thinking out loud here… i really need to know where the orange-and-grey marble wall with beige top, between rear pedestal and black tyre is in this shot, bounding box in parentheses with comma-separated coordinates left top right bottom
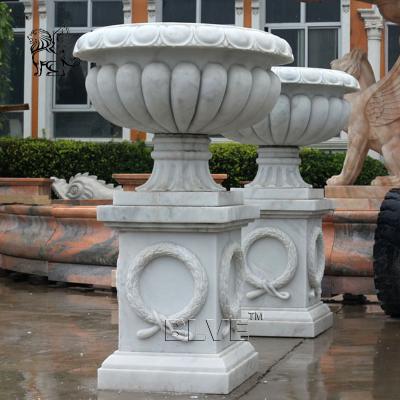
(323, 186, 392, 295)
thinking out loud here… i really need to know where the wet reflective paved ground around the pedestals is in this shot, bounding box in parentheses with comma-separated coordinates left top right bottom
(0, 277, 400, 400)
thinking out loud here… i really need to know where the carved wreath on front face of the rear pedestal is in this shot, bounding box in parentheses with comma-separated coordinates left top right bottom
(243, 228, 298, 300)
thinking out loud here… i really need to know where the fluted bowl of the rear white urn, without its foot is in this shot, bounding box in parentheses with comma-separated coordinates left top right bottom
(226, 67, 359, 146)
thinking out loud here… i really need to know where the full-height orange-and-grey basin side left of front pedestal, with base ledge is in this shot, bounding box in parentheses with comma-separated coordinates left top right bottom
(0, 200, 118, 287)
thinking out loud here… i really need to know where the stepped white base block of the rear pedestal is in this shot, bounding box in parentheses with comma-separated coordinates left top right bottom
(242, 303, 333, 338)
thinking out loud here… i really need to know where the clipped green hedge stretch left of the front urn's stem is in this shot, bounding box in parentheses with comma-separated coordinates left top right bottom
(0, 138, 153, 182)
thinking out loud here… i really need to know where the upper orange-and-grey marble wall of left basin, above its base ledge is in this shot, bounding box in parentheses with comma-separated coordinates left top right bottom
(0, 205, 118, 267)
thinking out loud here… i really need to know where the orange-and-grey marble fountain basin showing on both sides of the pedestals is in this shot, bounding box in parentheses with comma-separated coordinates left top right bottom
(0, 202, 376, 295)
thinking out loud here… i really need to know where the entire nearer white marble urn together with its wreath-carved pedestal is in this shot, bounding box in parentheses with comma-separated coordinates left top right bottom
(74, 23, 293, 393)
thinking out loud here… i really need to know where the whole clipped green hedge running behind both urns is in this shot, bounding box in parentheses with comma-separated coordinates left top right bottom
(0, 138, 387, 187)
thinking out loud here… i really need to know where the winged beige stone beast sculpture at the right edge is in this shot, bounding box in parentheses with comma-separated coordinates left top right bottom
(327, 49, 400, 185)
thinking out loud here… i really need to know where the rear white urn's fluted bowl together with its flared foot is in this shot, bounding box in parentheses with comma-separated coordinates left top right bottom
(226, 67, 359, 192)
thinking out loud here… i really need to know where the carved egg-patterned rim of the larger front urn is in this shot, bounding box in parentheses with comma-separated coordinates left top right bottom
(73, 22, 293, 65)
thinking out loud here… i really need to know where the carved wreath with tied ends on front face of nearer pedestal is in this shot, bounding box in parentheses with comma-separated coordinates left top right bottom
(125, 242, 208, 342)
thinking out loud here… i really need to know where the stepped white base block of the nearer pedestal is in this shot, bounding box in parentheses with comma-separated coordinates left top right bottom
(98, 342, 258, 394)
